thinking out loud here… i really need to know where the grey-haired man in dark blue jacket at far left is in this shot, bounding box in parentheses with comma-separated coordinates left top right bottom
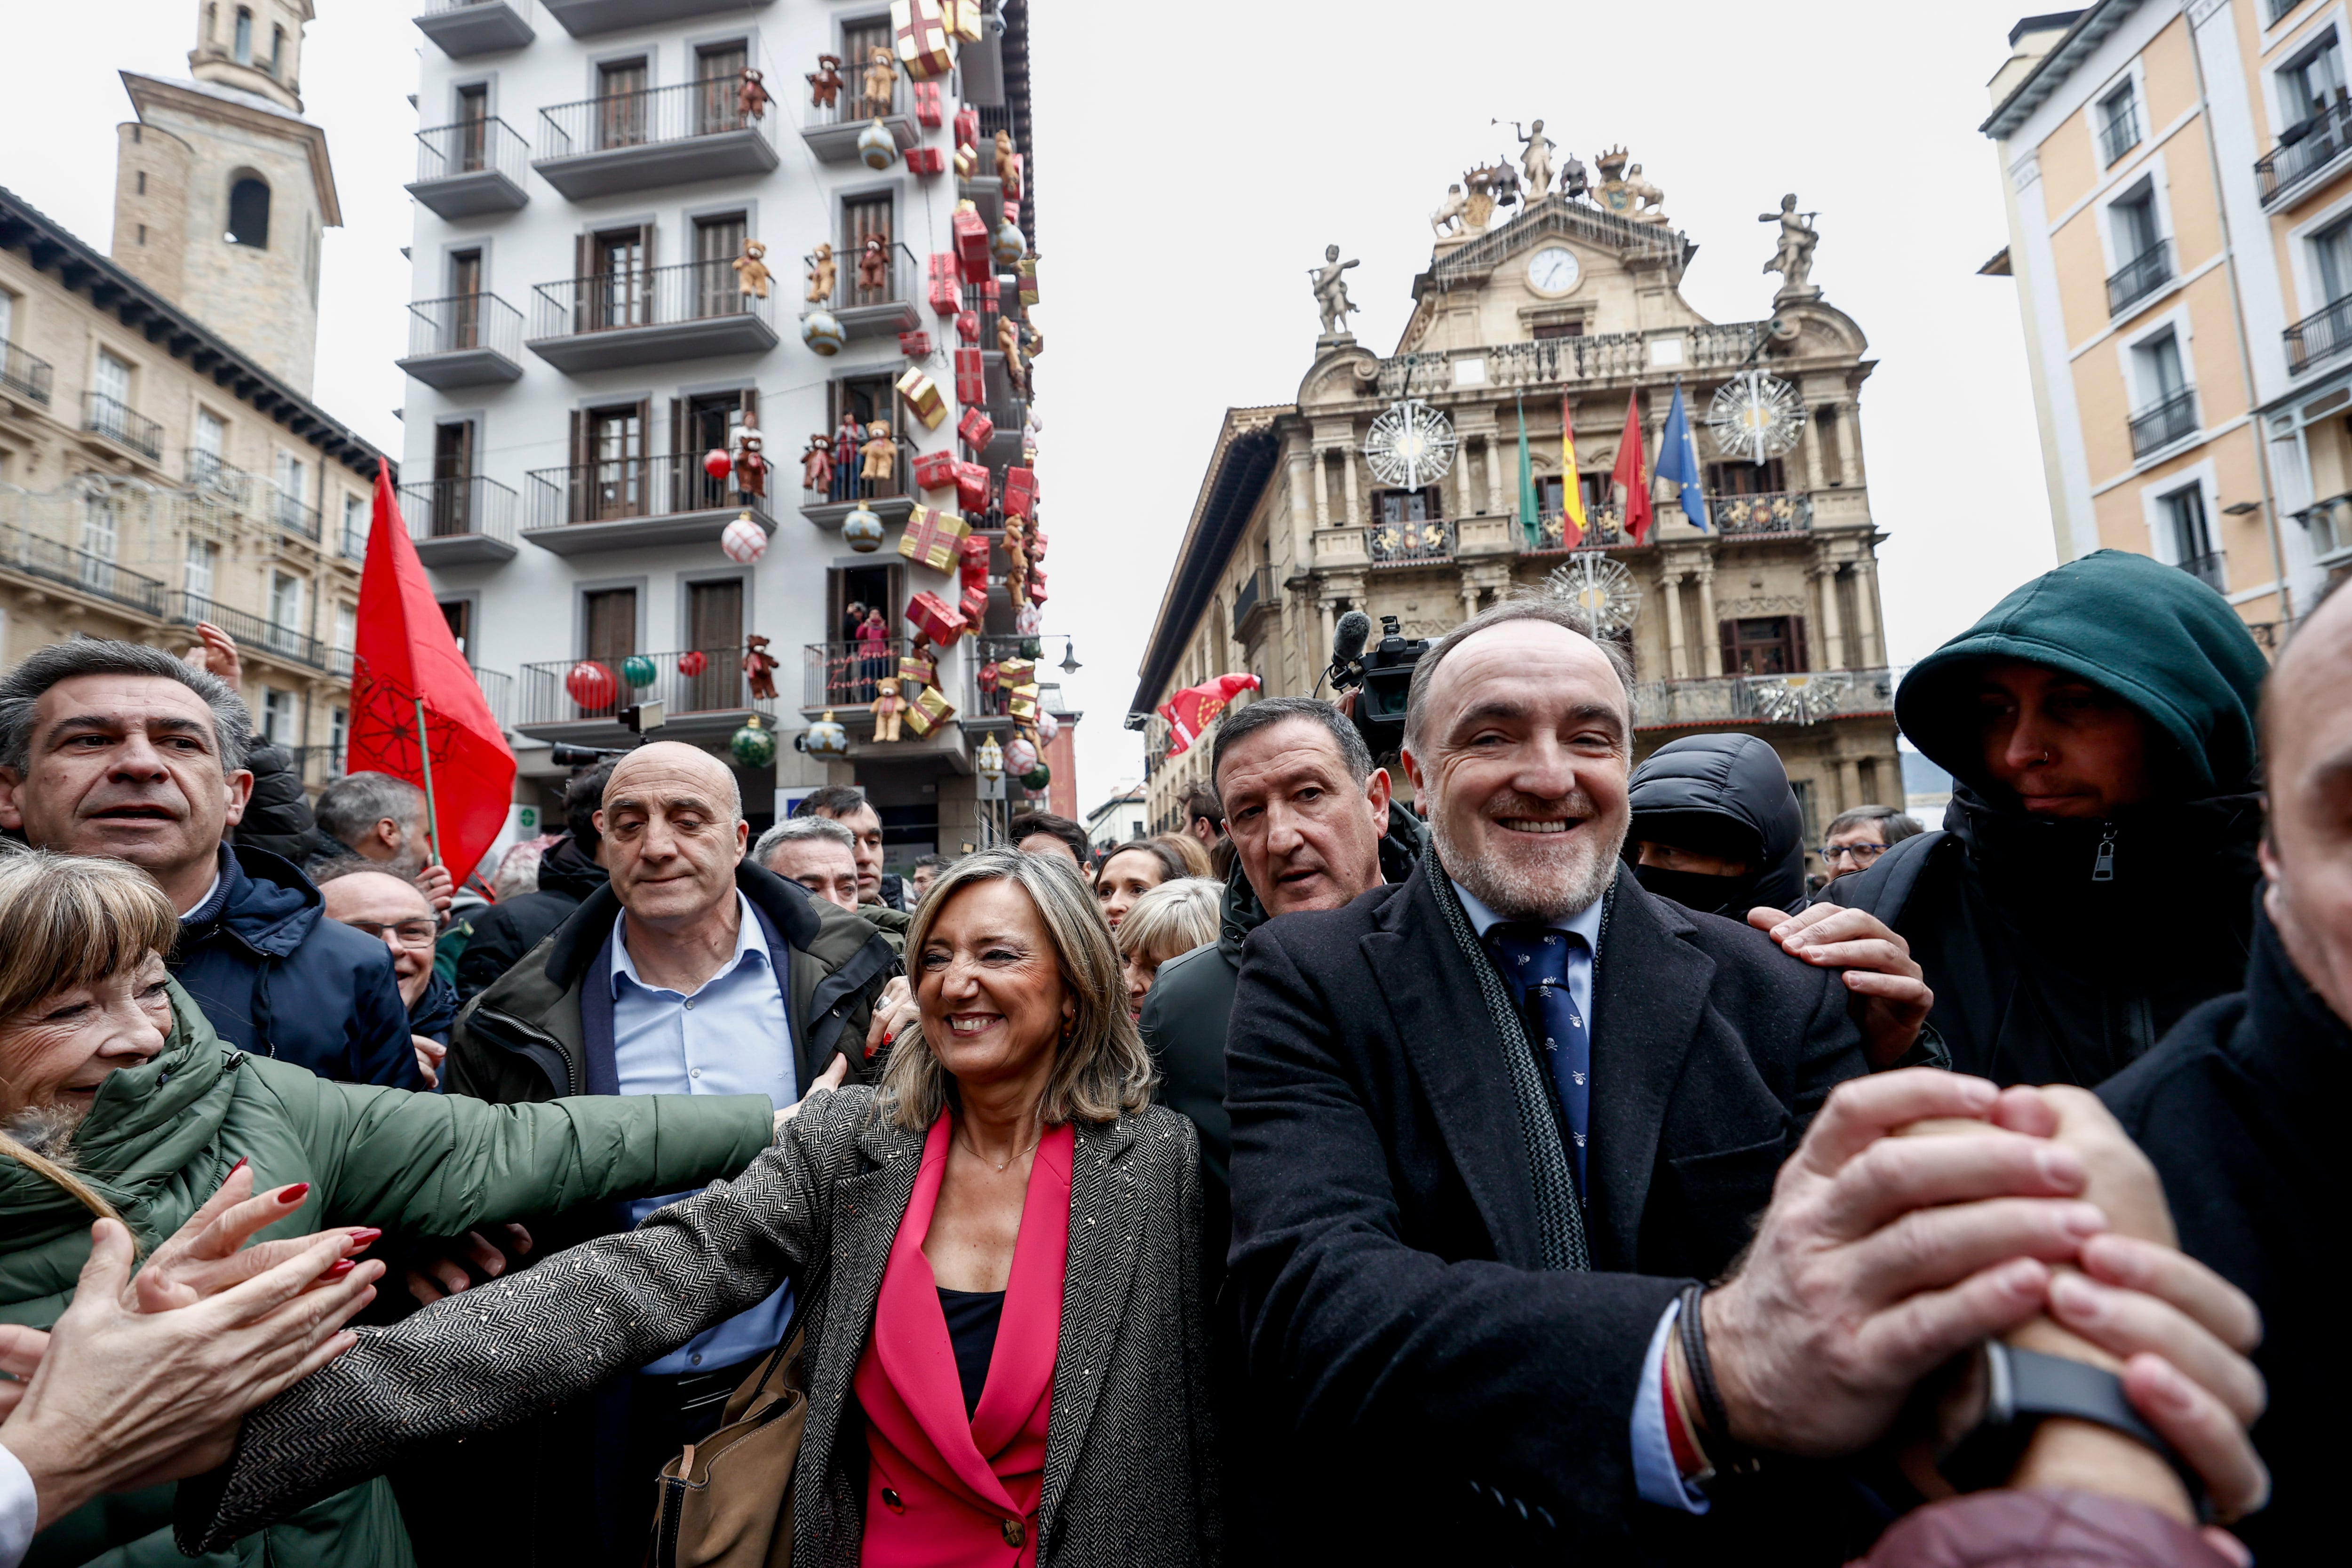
(0, 639, 421, 1089)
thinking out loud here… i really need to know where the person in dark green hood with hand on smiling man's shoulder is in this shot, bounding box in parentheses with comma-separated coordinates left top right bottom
(1788, 550, 2270, 1086)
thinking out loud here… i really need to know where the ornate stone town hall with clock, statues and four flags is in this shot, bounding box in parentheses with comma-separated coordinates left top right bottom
(1129, 175, 1903, 870)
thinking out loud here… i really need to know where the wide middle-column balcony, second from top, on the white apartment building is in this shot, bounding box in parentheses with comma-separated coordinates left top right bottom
(532, 73, 779, 202)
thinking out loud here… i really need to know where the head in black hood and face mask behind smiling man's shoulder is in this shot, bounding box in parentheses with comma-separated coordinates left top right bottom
(1625, 736, 1806, 919)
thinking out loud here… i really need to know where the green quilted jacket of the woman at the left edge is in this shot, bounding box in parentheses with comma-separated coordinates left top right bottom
(0, 983, 774, 1568)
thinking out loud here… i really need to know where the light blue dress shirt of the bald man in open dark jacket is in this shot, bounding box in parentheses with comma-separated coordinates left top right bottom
(609, 891, 800, 1375)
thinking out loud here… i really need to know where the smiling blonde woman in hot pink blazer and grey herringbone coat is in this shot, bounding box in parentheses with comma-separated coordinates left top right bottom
(181, 849, 1223, 1568)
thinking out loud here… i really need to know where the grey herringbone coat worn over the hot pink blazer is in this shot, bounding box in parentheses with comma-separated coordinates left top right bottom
(176, 1089, 1223, 1568)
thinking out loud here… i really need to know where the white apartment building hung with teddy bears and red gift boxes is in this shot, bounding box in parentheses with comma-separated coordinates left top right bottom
(402, 0, 1035, 865)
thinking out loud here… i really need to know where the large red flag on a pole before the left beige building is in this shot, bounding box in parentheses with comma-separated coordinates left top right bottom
(343, 468, 515, 882)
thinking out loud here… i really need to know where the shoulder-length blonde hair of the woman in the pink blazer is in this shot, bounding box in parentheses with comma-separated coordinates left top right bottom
(875, 849, 1155, 1133)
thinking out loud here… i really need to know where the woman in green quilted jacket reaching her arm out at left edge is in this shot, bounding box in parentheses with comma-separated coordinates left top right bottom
(0, 849, 776, 1568)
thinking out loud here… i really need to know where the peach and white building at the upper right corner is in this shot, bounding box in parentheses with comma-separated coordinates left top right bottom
(1983, 0, 2352, 646)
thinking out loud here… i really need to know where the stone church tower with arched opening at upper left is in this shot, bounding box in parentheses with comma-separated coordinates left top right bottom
(113, 0, 343, 397)
